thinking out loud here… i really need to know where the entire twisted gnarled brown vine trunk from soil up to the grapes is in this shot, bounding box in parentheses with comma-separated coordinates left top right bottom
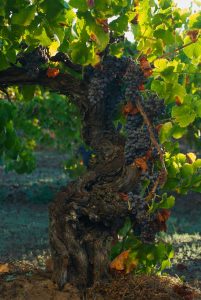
(50, 89, 137, 289)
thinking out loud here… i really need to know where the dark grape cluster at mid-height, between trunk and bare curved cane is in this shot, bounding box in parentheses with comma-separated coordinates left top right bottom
(124, 114, 151, 165)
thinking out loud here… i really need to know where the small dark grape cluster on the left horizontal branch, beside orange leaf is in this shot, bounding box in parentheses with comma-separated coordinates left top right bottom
(17, 46, 49, 78)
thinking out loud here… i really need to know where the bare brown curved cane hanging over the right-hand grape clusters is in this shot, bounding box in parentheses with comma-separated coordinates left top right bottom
(136, 98, 167, 191)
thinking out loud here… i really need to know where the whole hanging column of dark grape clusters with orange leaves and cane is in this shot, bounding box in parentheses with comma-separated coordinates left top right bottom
(88, 56, 165, 242)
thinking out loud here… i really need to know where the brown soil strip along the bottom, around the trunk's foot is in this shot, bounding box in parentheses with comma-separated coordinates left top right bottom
(0, 273, 201, 300)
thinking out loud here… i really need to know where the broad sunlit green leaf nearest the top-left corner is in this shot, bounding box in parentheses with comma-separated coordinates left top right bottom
(11, 5, 36, 26)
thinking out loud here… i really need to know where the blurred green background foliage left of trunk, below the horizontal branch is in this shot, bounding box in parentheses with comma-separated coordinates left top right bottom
(0, 87, 82, 173)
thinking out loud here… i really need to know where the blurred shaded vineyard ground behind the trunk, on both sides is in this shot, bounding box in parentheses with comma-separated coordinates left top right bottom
(0, 151, 201, 299)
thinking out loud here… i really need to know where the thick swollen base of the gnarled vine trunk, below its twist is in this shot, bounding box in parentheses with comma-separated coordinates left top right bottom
(50, 178, 133, 290)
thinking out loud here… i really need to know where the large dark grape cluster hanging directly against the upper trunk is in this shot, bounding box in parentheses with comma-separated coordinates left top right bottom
(85, 56, 128, 132)
